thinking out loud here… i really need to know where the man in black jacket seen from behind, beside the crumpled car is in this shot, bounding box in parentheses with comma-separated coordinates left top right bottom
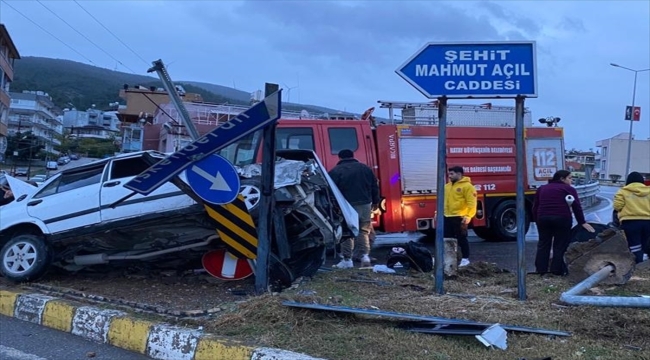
(329, 149, 379, 269)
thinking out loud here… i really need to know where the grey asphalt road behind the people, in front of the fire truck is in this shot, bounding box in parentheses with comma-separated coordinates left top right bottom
(372, 186, 619, 272)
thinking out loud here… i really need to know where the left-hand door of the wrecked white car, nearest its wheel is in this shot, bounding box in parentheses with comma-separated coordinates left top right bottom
(27, 162, 106, 234)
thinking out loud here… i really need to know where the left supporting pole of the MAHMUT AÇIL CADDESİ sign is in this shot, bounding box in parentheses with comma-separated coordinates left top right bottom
(435, 96, 447, 295)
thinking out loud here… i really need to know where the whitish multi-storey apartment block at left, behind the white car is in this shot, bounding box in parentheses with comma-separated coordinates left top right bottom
(8, 90, 63, 154)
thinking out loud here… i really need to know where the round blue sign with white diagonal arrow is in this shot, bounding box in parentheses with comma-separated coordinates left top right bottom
(185, 154, 240, 205)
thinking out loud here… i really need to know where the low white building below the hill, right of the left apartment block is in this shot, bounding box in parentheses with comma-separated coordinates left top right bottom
(63, 106, 120, 139)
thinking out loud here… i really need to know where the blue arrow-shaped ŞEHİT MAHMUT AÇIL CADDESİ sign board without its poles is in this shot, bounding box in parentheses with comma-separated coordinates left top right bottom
(395, 41, 537, 99)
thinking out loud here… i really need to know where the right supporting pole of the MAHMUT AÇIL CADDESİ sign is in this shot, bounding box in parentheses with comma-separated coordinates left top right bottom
(515, 96, 527, 300)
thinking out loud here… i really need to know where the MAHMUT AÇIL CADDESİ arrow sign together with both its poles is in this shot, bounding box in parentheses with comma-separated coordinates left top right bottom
(395, 41, 537, 300)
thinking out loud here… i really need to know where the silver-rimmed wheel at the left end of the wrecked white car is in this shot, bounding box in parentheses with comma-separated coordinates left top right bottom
(0, 235, 52, 282)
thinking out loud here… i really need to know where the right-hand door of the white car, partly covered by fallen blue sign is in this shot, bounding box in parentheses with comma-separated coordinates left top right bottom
(100, 153, 196, 222)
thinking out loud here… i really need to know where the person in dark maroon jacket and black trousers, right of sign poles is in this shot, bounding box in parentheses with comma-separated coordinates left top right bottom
(533, 170, 595, 275)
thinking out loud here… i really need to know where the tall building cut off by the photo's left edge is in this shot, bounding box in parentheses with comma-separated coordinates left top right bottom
(0, 24, 20, 161)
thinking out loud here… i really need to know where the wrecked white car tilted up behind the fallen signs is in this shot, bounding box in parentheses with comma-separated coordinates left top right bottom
(0, 150, 358, 282)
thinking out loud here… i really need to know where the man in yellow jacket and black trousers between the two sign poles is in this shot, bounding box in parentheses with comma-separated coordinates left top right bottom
(444, 166, 476, 266)
